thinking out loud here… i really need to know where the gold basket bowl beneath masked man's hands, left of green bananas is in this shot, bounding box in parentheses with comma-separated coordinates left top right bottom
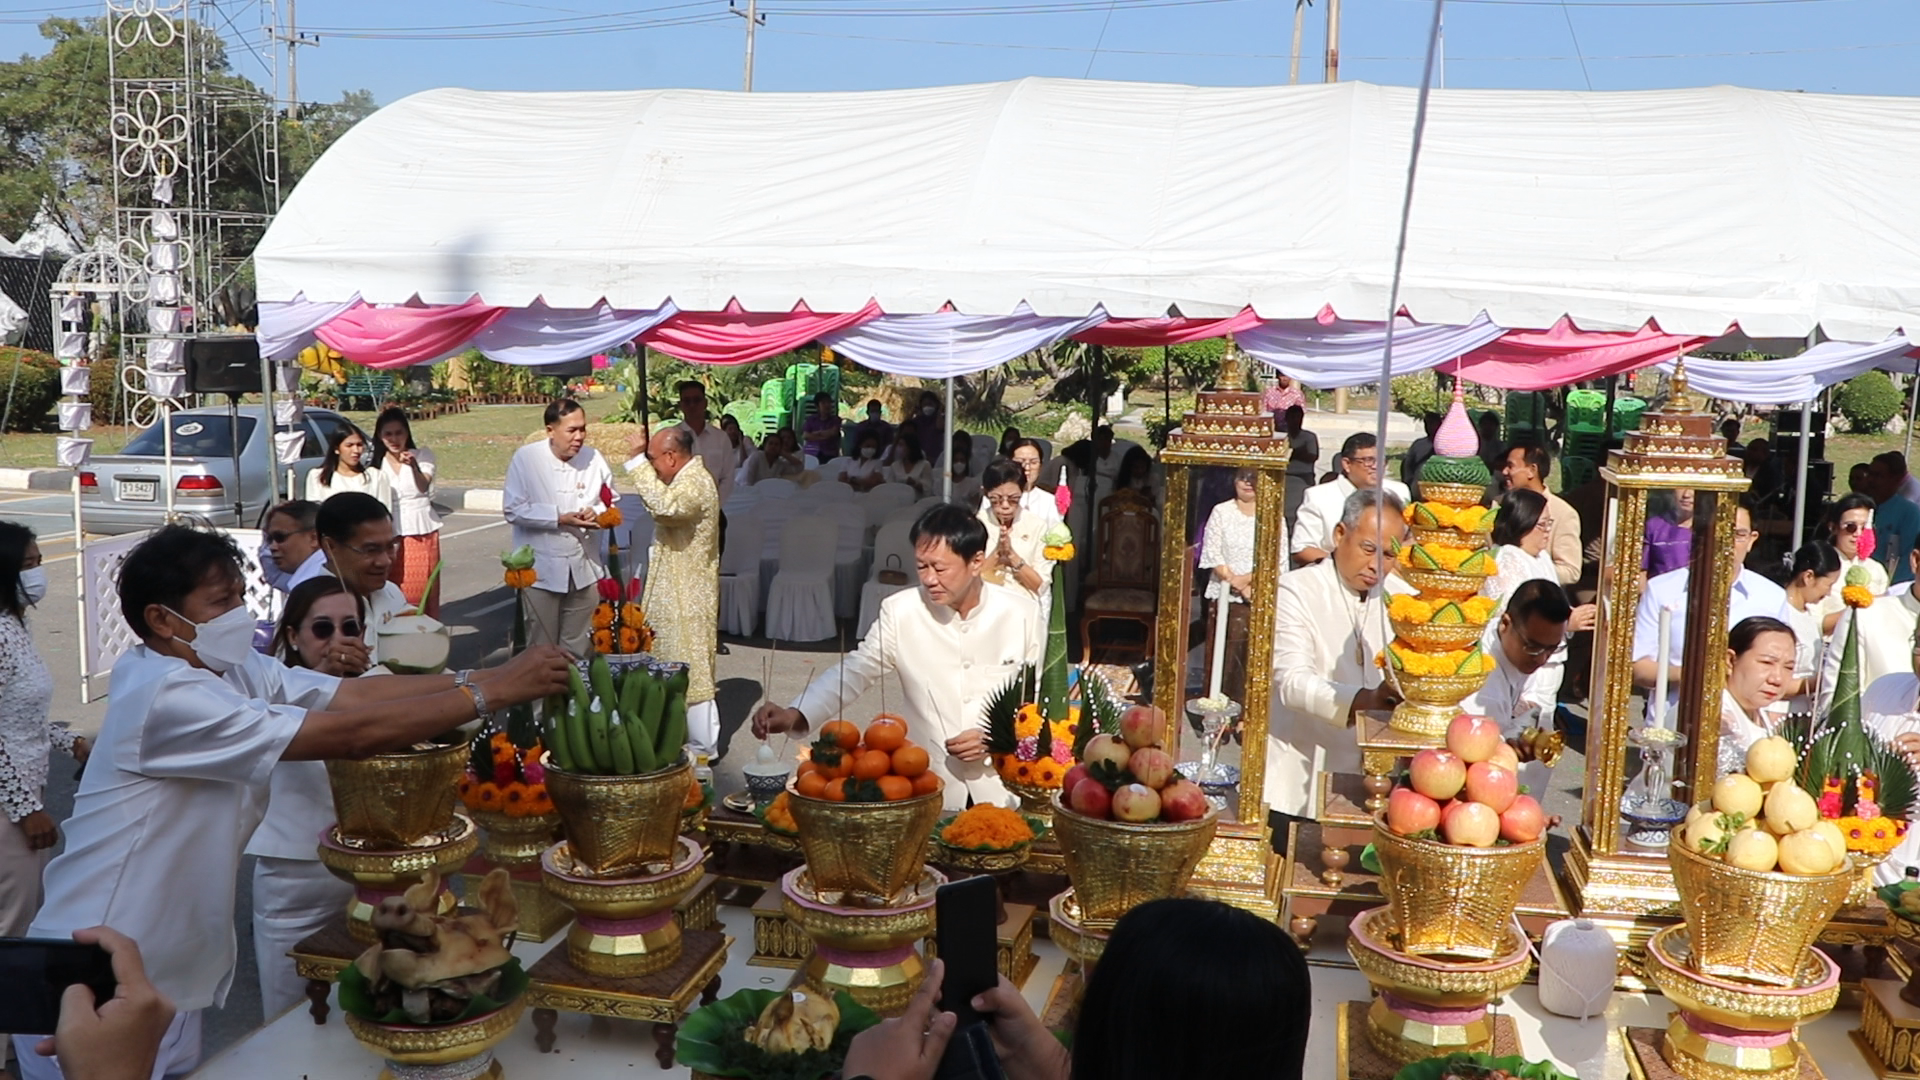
(326, 732, 472, 847)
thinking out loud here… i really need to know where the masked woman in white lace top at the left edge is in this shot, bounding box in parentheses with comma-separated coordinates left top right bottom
(0, 521, 88, 938)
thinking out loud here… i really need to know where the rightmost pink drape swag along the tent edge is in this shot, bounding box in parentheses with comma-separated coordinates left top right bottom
(1440, 319, 1709, 390)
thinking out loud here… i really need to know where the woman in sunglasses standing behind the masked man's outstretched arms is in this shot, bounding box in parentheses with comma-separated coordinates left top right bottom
(246, 575, 371, 1020)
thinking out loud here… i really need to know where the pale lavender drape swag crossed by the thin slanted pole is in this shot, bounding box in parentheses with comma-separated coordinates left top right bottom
(1233, 311, 1505, 388)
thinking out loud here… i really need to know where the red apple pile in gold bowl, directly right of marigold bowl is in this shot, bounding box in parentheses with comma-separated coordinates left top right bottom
(1060, 705, 1213, 824)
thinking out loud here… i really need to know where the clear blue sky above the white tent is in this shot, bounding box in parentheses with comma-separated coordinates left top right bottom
(0, 0, 1920, 102)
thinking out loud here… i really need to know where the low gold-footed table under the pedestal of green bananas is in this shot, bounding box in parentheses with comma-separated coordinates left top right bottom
(526, 930, 733, 1068)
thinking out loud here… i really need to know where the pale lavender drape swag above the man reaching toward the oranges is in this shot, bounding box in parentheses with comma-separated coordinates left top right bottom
(822, 304, 1106, 379)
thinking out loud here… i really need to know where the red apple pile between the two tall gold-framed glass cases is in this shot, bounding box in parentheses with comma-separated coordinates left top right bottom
(1386, 713, 1548, 847)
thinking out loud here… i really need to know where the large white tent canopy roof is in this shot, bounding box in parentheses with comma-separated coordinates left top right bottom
(255, 79, 1920, 342)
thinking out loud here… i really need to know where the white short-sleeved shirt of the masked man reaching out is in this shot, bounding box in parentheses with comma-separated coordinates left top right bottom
(29, 646, 340, 1013)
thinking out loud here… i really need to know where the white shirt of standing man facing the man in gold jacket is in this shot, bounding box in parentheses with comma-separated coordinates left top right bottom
(503, 440, 612, 592)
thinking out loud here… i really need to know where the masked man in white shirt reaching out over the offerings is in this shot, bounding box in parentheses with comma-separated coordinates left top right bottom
(13, 525, 572, 1080)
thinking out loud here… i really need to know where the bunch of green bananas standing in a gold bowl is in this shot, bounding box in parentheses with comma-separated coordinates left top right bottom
(543, 655, 687, 776)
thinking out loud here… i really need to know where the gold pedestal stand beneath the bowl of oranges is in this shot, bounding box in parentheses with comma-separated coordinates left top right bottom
(780, 867, 947, 1017)
